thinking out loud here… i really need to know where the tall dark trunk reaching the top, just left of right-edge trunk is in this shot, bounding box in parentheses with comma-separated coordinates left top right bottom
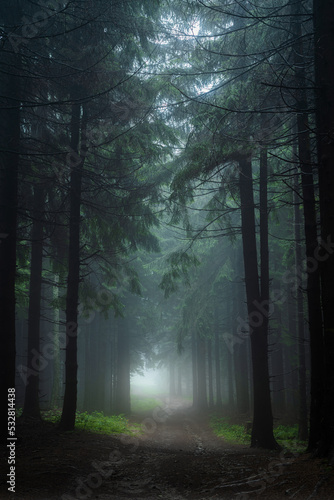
(291, 2, 324, 451)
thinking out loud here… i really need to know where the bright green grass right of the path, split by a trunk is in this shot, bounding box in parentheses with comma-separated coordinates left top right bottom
(210, 416, 306, 452)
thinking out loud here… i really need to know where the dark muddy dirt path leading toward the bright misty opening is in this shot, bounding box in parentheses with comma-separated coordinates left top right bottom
(64, 399, 334, 500)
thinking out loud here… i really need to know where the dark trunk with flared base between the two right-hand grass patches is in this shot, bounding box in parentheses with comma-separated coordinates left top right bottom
(239, 156, 279, 449)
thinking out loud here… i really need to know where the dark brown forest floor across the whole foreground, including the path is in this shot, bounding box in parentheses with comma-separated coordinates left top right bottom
(0, 401, 334, 500)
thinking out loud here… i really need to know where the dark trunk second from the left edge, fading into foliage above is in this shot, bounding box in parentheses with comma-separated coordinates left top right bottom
(23, 183, 45, 418)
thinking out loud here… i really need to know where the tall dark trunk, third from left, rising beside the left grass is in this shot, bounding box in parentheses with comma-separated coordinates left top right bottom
(60, 99, 86, 430)
